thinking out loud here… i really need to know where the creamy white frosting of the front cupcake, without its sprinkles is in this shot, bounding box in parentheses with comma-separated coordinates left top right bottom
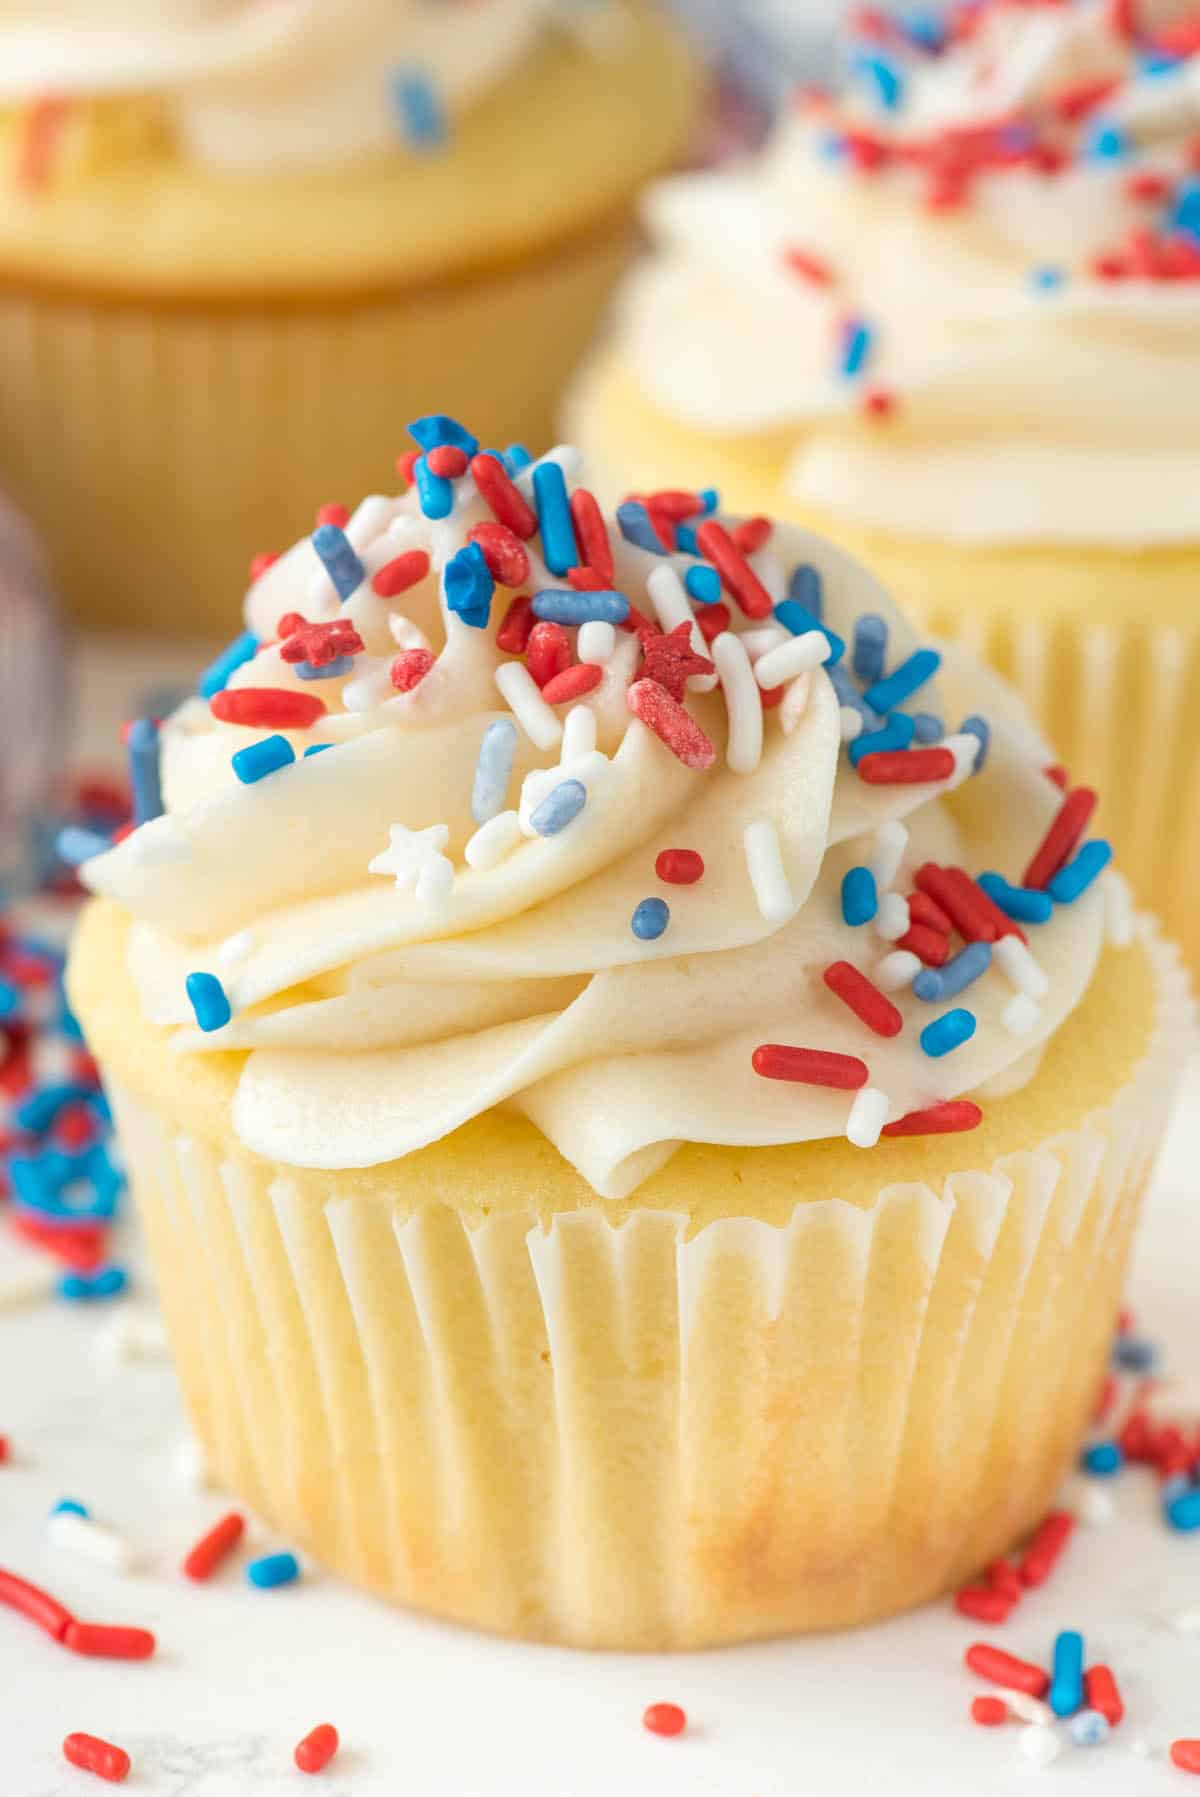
(84, 440, 1103, 1197)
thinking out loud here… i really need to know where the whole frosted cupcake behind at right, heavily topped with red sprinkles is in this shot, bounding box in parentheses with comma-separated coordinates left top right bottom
(569, 0, 1200, 956)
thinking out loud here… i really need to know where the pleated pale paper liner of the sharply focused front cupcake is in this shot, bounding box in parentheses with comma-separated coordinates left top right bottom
(115, 925, 1191, 1650)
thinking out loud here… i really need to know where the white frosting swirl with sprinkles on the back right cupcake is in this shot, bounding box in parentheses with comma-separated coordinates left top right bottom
(618, 0, 1200, 546)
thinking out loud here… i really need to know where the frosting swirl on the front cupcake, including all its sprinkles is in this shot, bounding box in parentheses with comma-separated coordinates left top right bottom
(72, 417, 1125, 1199)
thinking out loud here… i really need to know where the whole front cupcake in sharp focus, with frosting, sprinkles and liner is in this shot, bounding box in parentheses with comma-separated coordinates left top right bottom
(70, 417, 1189, 1650)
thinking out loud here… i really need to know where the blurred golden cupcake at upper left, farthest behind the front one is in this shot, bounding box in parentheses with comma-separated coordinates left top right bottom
(0, 0, 697, 640)
